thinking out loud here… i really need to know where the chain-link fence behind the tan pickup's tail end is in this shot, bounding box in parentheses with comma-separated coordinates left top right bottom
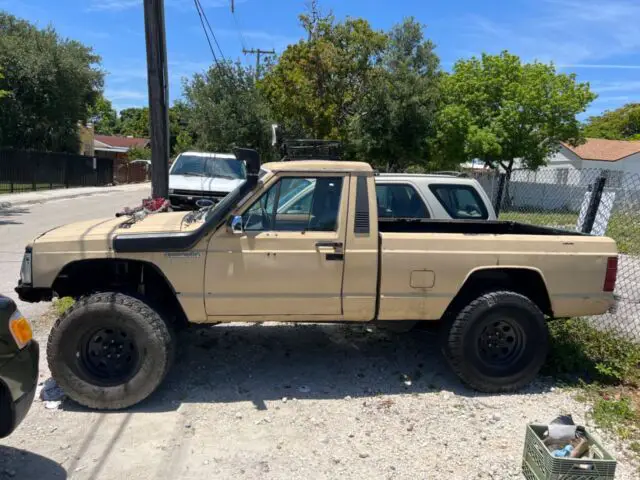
(470, 168, 640, 342)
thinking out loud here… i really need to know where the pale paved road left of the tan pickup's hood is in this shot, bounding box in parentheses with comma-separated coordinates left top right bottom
(0, 184, 150, 317)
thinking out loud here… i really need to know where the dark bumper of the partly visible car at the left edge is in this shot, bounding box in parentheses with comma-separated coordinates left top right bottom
(0, 340, 40, 438)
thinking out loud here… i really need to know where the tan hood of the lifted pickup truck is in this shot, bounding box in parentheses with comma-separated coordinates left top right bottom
(34, 212, 190, 253)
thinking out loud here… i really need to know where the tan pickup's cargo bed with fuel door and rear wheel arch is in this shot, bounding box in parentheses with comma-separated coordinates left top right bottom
(378, 219, 616, 320)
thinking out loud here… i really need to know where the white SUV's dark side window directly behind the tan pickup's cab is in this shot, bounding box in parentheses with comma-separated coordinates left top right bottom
(376, 183, 430, 220)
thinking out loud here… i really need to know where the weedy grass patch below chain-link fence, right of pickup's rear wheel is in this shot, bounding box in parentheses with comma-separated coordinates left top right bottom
(544, 318, 640, 460)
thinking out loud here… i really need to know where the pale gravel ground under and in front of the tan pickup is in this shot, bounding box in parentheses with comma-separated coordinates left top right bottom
(0, 318, 638, 480)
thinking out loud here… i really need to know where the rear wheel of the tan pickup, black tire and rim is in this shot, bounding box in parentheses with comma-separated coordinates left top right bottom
(443, 291, 549, 393)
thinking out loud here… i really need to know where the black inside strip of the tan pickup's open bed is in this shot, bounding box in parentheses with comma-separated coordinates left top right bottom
(378, 219, 586, 236)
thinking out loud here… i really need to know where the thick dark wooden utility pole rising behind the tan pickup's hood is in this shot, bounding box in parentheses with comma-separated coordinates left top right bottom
(144, 0, 169, 198)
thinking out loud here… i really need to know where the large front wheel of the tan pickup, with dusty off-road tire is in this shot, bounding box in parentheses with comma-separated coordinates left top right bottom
(47, 292, 175, 410)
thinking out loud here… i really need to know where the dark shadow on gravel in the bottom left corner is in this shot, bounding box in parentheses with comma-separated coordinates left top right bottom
(0, 445, 67, 480)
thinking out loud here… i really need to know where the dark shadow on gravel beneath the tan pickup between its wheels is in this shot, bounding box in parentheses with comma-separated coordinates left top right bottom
(63, 324, 551, 412)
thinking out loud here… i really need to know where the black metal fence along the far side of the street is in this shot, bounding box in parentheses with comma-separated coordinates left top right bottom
(0, 149, 113, 194)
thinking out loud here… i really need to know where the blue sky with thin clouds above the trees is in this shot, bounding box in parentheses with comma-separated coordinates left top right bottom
(0, 0, 640, 116)
